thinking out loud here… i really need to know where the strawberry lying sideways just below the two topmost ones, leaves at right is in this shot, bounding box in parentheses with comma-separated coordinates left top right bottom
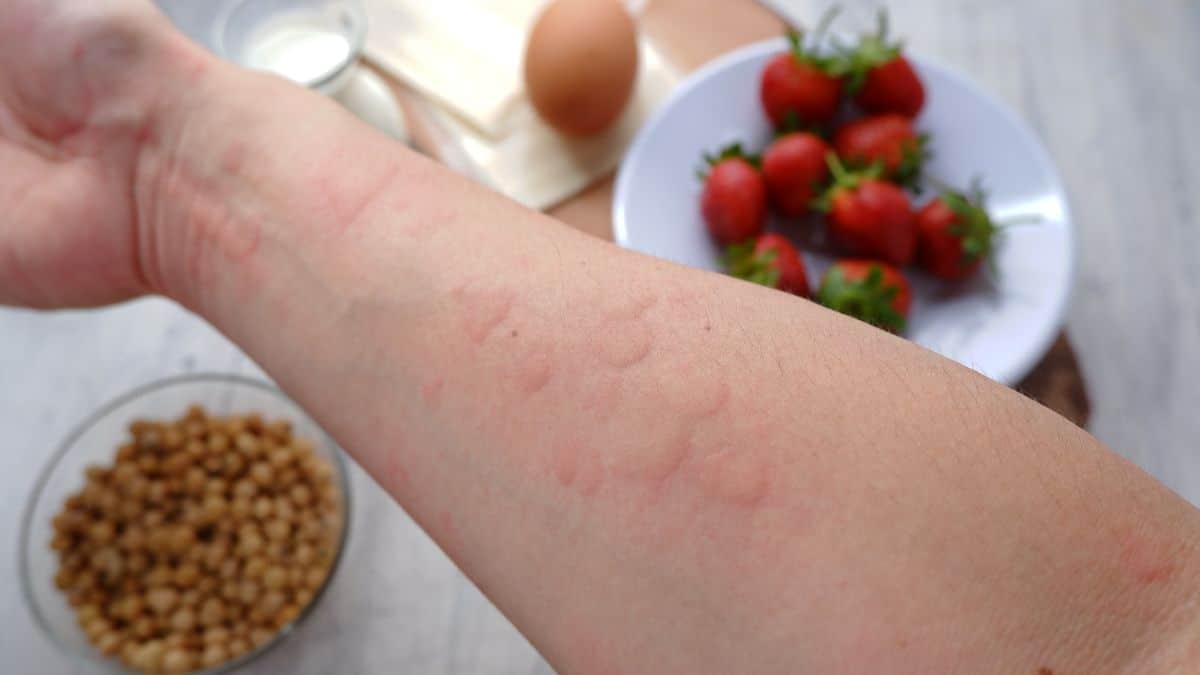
(833, 114, 928, 186)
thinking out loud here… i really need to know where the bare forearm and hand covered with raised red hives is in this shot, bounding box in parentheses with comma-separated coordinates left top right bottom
(0, 0, 1200, 675)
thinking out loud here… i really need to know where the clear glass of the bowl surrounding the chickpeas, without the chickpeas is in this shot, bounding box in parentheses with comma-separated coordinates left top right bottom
(19, 375, 350, 674)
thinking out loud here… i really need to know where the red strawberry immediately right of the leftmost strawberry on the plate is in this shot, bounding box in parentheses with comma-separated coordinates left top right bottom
(762, 132, 829, 216)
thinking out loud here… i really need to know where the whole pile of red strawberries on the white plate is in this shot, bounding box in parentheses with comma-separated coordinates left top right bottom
(701, 14, 997, 333)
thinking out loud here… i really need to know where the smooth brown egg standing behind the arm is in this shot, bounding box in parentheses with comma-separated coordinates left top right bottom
(524, 0, 637, 136)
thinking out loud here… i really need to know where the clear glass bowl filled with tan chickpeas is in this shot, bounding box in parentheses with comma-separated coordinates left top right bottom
(19, 375, 350, 673)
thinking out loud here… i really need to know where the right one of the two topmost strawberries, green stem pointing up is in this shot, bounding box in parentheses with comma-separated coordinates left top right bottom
(841, 11, 925, 118)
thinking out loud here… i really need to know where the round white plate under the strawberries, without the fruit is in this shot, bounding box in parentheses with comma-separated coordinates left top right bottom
(613, 38, 1075, 384)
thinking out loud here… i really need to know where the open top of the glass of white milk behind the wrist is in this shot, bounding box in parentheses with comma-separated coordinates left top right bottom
(212, 0, 367, 96)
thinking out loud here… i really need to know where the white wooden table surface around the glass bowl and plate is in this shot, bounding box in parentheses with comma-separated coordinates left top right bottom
(0, 0, 1200, 675)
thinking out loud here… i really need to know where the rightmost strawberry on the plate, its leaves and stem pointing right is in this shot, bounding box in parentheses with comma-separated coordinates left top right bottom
(917, 180, 1000, 281)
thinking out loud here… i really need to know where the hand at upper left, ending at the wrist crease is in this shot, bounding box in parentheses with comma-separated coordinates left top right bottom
(0, 0, 206, 307)
